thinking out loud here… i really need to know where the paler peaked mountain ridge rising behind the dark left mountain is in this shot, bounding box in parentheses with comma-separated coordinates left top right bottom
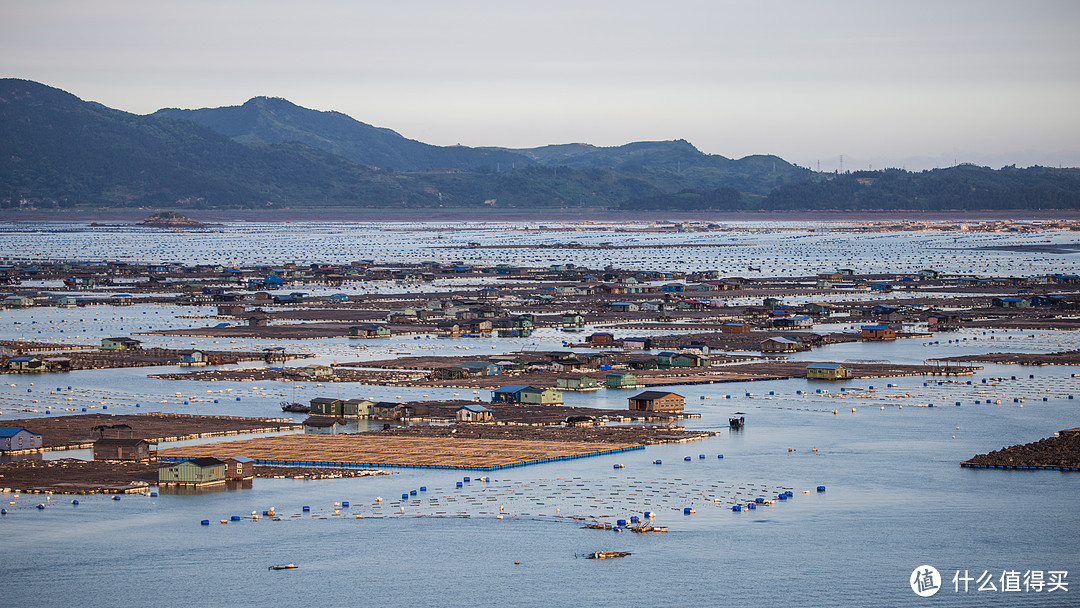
(152, 97, 532, 171)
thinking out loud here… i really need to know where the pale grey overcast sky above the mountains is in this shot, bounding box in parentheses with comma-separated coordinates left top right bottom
(0, 0, 1080, 171)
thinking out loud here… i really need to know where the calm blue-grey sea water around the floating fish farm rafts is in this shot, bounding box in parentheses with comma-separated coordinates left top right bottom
(0, 225, 1080, 607)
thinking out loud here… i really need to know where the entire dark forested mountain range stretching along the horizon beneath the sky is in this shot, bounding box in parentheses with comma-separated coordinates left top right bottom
(0, 79, 1080, 211)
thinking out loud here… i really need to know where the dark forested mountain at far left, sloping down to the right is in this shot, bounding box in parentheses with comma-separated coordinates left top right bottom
(0, 79, 402, 207)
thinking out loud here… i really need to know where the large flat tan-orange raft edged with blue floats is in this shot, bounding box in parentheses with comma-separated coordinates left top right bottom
(158, 433, 645, 471)
